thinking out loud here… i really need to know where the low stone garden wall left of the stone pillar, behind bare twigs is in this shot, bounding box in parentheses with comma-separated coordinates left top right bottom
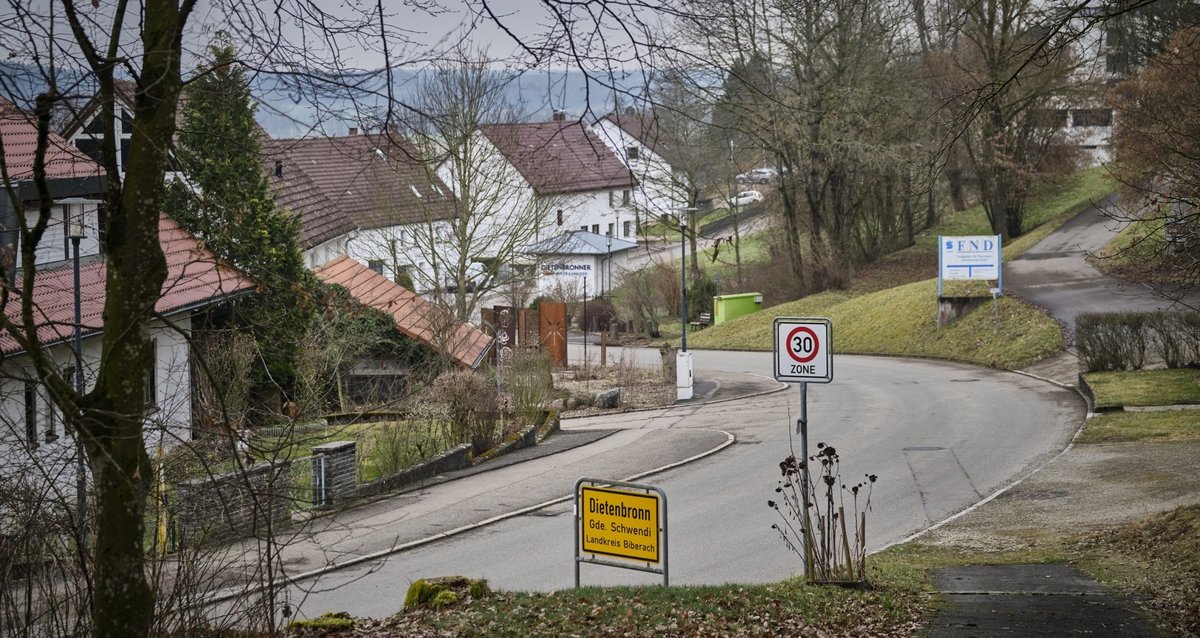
(175, 462, 292, 547)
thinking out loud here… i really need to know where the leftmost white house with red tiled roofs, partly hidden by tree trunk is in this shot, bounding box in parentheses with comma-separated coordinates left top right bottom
(0, 103, 254, 480)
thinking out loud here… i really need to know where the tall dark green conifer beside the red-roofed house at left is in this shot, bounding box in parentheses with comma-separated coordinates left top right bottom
(167, 34, 316, 395)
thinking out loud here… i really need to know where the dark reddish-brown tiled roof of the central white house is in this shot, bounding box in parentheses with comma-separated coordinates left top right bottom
(480, 121, 636, 195)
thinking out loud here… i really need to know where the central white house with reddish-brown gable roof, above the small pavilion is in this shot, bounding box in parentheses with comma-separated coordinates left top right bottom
(463, 115, 637, 241)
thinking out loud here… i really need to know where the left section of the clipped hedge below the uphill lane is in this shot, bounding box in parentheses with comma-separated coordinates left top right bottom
(1075, 312, 1148, 372)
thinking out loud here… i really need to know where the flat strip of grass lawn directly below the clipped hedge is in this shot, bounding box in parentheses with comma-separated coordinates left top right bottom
(1084, 368, 1200, 409)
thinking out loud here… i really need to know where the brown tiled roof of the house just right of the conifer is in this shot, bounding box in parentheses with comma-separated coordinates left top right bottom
(263, 134, 455, 239)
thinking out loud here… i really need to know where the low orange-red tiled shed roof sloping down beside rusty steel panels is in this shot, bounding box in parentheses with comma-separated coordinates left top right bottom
(313, 257, 492, 368)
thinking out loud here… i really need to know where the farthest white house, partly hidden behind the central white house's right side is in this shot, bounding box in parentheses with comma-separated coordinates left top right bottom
(592, 107, 688, 225)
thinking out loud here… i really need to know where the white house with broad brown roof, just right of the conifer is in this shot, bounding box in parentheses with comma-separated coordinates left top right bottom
(263, 133, 455, 291)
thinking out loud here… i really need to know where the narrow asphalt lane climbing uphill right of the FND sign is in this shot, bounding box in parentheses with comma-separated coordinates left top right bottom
(1004, 198, 1200, 330)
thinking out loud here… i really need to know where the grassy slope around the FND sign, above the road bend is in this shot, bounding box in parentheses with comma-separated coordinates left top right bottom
(689, 169, 1111, 368)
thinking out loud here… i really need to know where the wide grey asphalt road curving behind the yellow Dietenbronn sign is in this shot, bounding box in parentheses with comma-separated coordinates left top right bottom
(290, 350, 1084, 616)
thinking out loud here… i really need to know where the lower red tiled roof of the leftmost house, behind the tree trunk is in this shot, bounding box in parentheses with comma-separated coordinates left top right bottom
(0, 215, 254, 355)
